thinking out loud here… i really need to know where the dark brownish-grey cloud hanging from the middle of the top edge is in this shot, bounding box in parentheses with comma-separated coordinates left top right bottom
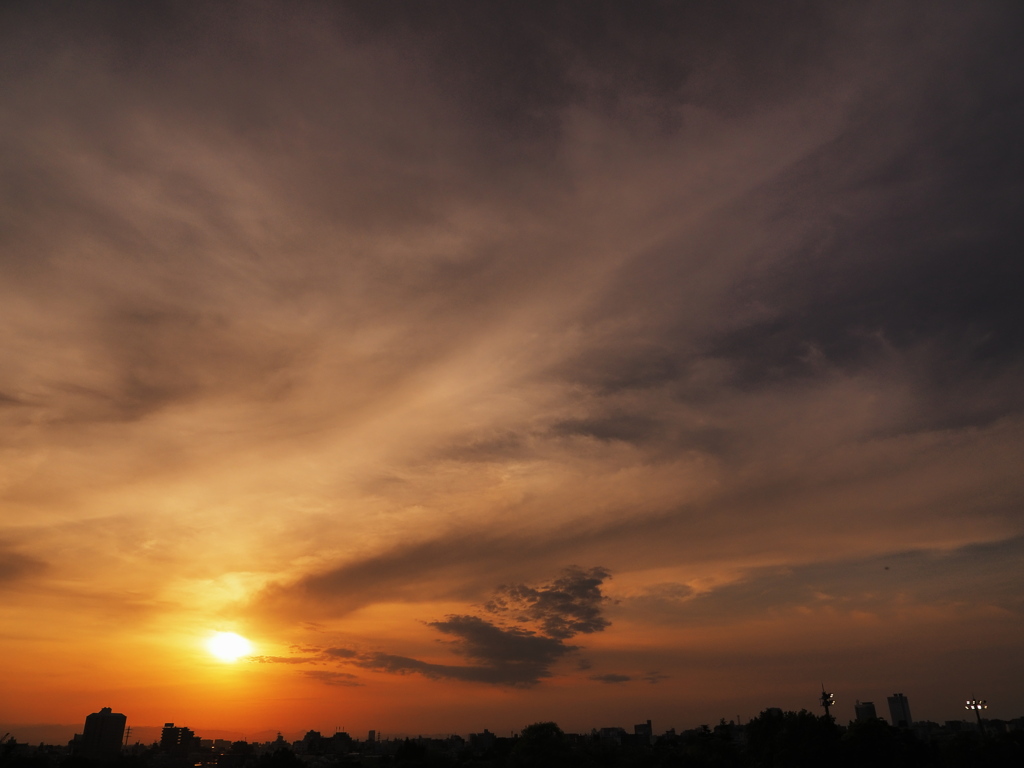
(335, 0, 856, 132)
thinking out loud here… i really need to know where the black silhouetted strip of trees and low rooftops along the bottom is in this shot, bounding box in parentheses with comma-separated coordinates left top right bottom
(0, 710, 1024, 768)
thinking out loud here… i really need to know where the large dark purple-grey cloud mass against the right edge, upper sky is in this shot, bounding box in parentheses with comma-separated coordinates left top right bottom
(563, 6, 1024, 438)
